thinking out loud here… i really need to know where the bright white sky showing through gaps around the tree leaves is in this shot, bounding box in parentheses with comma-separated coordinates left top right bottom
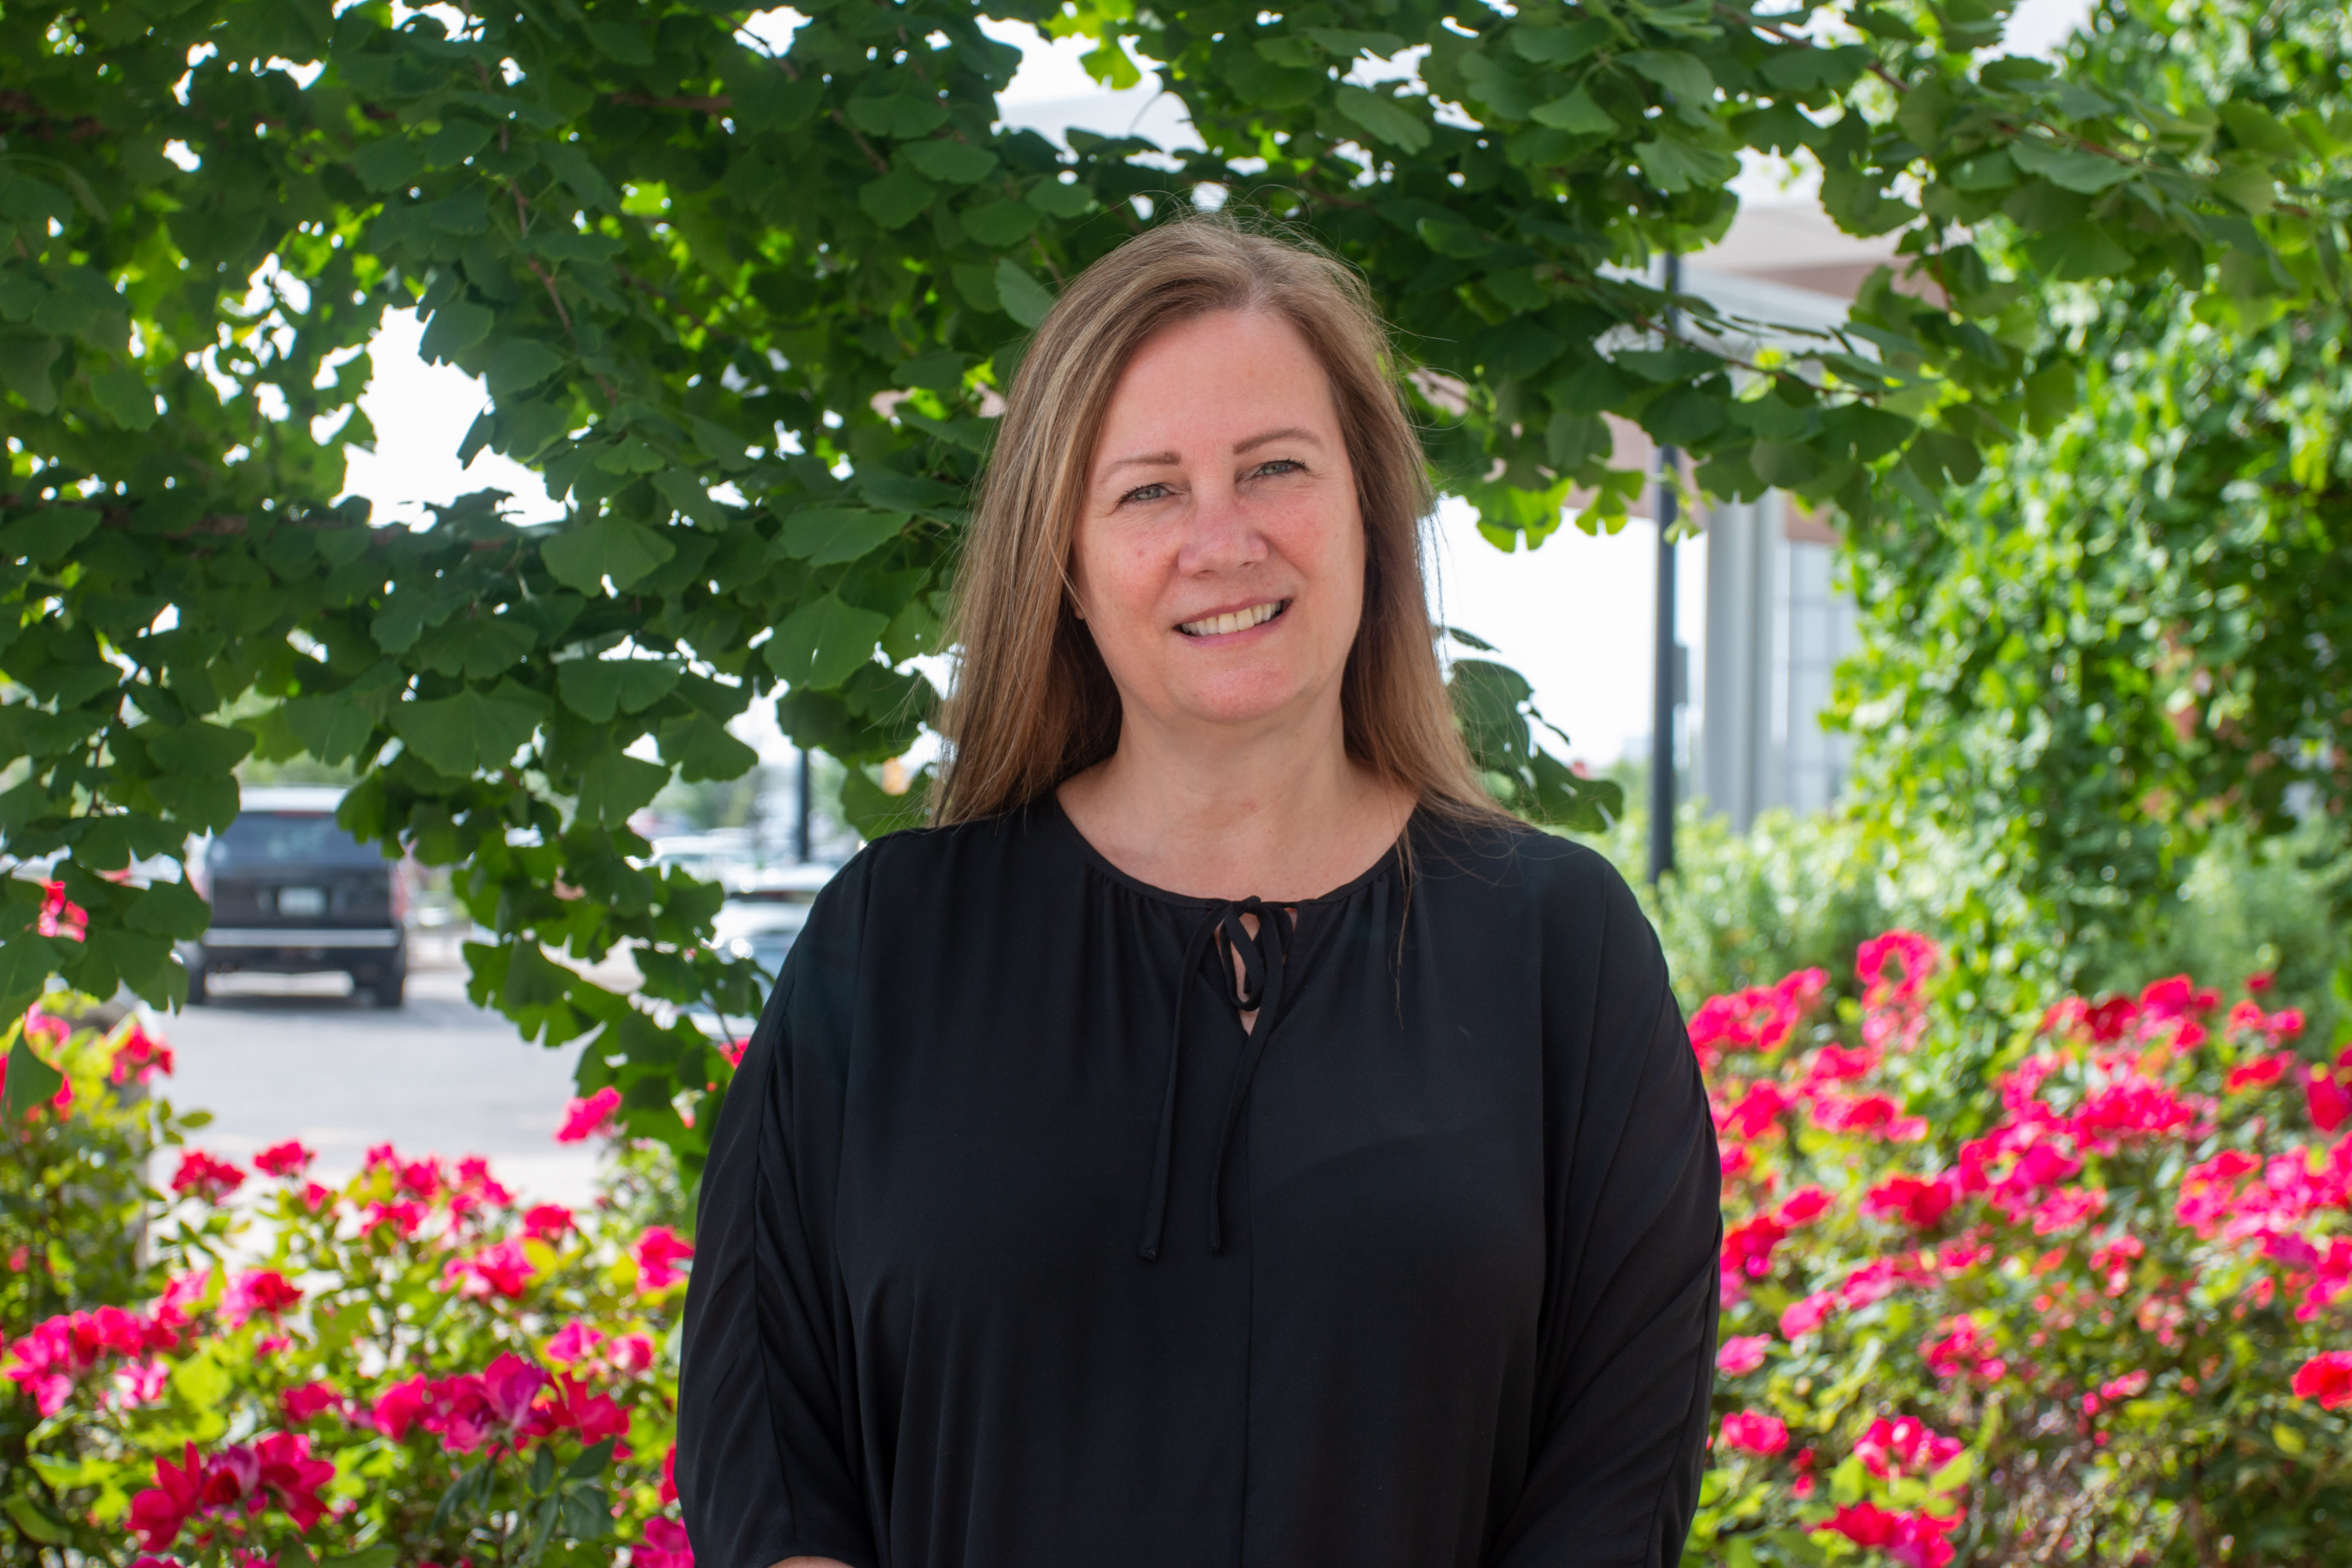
(348, 0, 2089, 764)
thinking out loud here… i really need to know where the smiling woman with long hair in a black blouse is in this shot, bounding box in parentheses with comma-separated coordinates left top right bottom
(677, 219, 1719, 1568)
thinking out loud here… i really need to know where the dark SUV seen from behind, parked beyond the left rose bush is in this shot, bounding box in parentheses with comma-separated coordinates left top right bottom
(184, 787, 409, 1006)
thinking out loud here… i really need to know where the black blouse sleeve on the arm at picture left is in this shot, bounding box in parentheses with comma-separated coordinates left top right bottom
(677, 863, 880, 1568)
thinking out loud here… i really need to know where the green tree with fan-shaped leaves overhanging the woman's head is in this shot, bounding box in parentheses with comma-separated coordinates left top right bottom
(0, 0, 2340, 1166)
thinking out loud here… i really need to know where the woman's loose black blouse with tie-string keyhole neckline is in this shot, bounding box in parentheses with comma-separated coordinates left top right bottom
(677, 799, 1722, 1568)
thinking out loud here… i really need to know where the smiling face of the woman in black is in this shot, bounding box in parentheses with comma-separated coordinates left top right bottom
(1075, 310, 1364, 747)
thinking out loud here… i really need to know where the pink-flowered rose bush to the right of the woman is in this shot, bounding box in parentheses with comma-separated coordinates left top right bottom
(1691, 931, 2352, 1568)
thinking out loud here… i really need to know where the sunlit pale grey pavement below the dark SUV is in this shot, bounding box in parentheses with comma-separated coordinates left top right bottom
(158, 949, 595, 1204)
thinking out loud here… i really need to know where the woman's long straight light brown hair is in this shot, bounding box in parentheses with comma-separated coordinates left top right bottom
(934, 214, 1501, 823)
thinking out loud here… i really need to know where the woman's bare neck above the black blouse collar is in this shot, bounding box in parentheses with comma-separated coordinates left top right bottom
(1061, 705, 1414, 900)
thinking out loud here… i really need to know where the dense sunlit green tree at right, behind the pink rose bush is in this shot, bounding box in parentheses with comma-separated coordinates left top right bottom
(1844, 0, 2352, 978)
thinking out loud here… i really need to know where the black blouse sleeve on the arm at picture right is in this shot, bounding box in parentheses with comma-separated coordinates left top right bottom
(1494, 863, 1722, 1568)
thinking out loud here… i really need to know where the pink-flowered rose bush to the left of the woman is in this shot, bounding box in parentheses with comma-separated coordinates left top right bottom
(0, 1001, 694, 1568)
